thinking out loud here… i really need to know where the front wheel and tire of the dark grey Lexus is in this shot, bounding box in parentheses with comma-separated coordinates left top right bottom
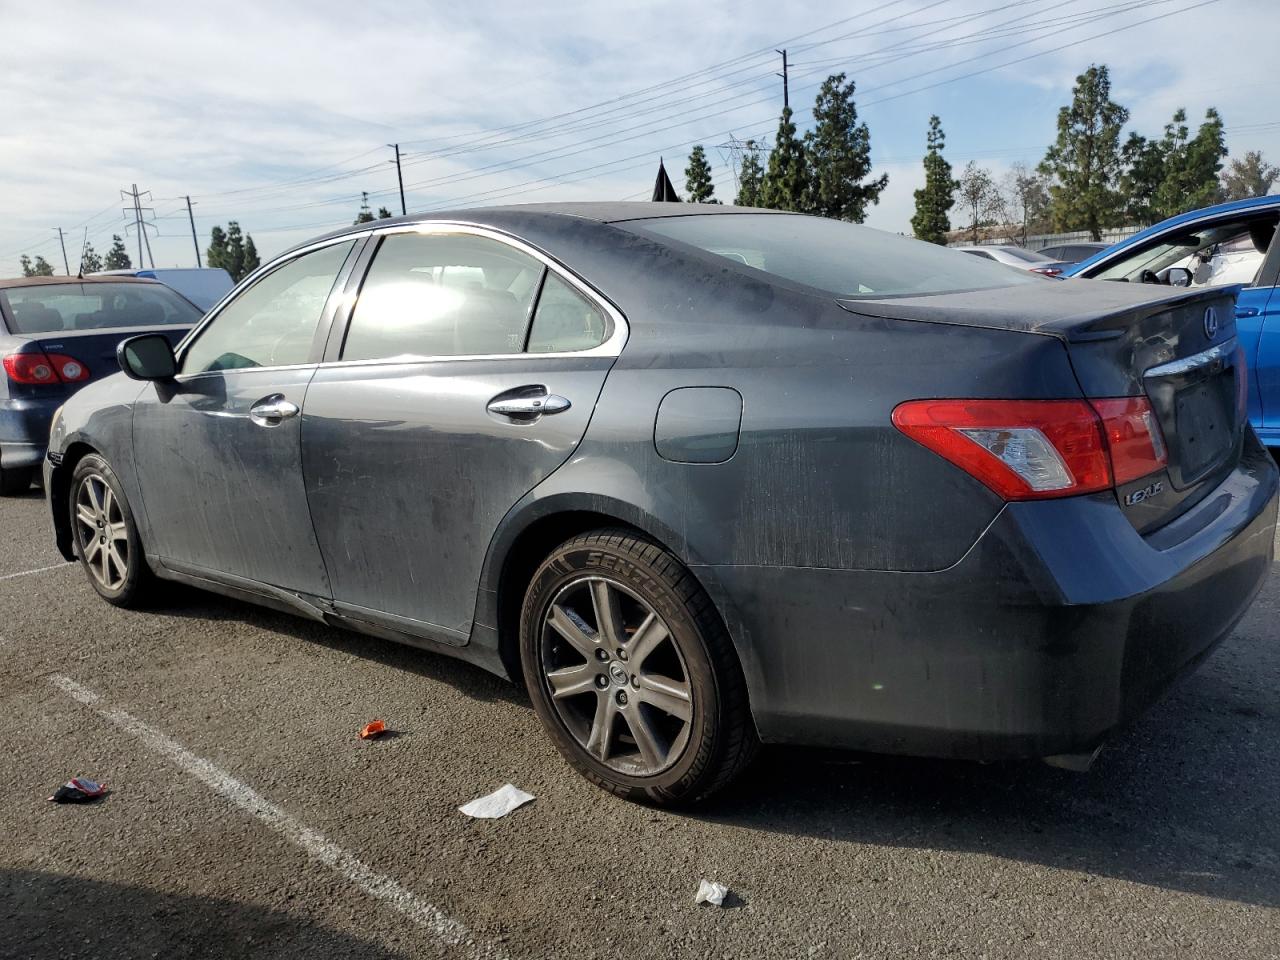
(67, 453, 155, 607)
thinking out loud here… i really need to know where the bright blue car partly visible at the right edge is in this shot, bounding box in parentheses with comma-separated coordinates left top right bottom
(1064, 196, 1280, 447)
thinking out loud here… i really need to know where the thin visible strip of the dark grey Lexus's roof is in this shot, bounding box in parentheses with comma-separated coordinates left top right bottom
(294, 200, 800, 256)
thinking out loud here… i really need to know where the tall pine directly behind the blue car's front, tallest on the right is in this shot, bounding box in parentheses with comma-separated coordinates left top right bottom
(1039, 65, 1129, 241)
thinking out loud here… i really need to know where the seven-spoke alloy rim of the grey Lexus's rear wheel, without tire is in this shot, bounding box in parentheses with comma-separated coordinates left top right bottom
(540, 576, 696, 777)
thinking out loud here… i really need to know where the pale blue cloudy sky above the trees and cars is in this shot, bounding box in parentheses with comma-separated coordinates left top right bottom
(0, 0, 1280, 275)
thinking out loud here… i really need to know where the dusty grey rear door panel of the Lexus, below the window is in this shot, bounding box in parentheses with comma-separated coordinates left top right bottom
(302, 355, 613, 643)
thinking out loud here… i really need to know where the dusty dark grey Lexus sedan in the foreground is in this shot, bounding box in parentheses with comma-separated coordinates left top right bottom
(45, 204, 1280, 803)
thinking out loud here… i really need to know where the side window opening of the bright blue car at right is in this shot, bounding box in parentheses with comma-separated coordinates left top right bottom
(1088, 214, 1276, 287)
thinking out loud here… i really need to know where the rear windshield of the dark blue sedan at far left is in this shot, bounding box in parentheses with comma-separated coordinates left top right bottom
(0, 282, 201, 333)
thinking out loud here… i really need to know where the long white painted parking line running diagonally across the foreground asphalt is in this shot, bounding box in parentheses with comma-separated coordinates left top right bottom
(50, 675, 504, 960)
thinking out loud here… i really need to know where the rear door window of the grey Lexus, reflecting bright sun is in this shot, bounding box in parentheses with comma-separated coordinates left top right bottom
(342, 233, 549, 360)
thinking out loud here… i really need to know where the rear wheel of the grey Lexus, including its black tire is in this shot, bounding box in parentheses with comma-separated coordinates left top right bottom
(520, 530, 758, 805)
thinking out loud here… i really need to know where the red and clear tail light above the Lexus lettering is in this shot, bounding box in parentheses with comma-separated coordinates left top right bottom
(893, 397, 1167, 500)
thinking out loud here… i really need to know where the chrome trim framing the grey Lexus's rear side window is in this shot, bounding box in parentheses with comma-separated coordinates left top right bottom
(332, 220, 631, 367)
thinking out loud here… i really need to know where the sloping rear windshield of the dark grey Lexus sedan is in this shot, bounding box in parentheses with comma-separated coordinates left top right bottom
(616, 214, 1044, 298)
